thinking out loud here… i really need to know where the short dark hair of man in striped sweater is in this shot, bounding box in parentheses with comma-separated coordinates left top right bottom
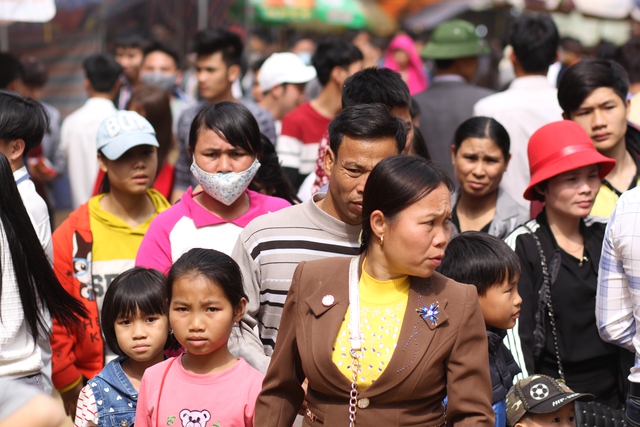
(329, 104, 407, 158)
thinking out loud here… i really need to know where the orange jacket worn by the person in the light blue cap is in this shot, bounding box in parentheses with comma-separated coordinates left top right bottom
(51, 203, 104, 389)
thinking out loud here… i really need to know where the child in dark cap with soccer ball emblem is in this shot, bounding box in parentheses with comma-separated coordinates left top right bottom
(507, 375, 594, 427)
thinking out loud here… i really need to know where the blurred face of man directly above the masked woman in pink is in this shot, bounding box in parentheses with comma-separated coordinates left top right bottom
(196, 52, 239, 102)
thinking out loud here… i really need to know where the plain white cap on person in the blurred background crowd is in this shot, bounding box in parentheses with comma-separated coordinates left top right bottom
(258, 52, 316, 92)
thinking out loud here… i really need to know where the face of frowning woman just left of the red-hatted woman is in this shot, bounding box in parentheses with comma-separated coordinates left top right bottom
(451, 138, 508, 197)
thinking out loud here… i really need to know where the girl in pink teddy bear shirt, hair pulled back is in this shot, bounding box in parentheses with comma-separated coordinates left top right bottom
(135, 248, 264, 427)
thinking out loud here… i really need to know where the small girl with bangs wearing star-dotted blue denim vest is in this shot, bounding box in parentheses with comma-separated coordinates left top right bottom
(75, 267, 169, 427)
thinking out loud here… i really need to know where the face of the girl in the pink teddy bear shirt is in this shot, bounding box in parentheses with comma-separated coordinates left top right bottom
(169, 275, 246, 356)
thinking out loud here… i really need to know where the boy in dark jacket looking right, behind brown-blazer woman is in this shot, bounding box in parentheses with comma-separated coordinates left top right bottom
(437, 231, 522, 427)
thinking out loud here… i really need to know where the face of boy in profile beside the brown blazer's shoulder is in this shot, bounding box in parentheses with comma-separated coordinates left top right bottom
(478, 276, 522, 329)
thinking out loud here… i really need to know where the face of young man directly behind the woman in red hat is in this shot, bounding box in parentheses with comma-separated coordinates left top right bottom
(571, 87, 629, 155)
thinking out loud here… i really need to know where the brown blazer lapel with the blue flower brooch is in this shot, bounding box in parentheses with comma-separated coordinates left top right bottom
(362, 277, 449, 397)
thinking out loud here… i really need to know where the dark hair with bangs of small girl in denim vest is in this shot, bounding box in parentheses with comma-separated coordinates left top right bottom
(101, 267, 176, 356)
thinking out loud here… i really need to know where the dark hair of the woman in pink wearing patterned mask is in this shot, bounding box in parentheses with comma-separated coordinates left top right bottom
(189, 101, 263, 159)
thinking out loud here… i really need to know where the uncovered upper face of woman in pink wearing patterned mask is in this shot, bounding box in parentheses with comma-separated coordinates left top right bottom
(193, 128, 255, 173)
